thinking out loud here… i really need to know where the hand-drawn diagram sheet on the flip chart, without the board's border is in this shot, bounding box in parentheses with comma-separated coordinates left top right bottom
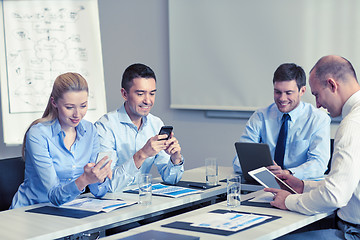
(4, 1, 102, 113)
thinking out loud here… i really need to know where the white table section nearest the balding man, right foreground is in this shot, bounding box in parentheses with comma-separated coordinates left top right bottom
(103, 190, 332, 240)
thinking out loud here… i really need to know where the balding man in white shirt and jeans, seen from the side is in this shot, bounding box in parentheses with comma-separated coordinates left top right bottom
(265, 56, 360, 239)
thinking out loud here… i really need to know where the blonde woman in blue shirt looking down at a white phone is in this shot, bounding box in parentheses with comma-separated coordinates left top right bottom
(10, 73, 112, 208)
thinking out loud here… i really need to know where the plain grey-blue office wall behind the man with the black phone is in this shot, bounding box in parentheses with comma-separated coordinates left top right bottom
(0, 0, 338, 178)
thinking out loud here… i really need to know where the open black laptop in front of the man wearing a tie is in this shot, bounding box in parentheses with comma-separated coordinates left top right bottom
(235, 142, 273, 184)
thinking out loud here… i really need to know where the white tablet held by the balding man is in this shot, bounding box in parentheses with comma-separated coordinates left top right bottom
(249, 167, 297, 194)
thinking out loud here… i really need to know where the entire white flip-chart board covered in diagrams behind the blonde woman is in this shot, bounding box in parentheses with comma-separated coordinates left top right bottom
(0, 0, 106, 145)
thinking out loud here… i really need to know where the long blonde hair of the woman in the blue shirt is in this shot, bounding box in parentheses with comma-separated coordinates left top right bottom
(22, 72, 89, 160)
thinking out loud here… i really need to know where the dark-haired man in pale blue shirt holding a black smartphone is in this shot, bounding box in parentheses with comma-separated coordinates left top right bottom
(95, 63, 184, 192)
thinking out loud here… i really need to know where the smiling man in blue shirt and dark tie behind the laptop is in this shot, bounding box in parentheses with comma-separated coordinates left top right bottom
(233, 63, 330, 179)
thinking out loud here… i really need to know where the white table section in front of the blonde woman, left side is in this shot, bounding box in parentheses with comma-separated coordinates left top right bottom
(0, 166, 260, 240)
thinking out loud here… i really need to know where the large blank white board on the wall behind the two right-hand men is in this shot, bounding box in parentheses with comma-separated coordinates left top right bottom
(169, 0, 360, 111)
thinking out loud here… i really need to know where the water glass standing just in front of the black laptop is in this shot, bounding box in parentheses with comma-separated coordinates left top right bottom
(226, 175, 241, 208)
